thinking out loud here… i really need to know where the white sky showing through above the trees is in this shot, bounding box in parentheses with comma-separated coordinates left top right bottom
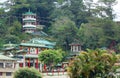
(0, 0, 120, 21)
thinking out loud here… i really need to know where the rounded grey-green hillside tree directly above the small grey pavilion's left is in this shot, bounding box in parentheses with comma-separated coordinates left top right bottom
(50, 17, 78, 50)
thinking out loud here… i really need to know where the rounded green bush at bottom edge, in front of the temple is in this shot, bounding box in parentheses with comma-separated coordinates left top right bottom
(13, 68, 42, 78)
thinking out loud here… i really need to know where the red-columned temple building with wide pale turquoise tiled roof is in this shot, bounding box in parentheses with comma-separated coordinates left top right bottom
(17, 38, 56, 70)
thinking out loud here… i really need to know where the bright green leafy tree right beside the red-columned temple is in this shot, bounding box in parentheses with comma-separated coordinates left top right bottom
(39, 49, 64, 66)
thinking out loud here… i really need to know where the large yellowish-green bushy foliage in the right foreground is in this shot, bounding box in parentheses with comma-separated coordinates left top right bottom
(68, 49, 118, 78)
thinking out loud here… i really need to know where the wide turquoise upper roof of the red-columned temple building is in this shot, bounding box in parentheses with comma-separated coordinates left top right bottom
(20, 38, 56, 48)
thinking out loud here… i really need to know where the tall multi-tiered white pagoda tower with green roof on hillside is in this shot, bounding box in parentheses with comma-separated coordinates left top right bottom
(22, 10, 37, 33)
